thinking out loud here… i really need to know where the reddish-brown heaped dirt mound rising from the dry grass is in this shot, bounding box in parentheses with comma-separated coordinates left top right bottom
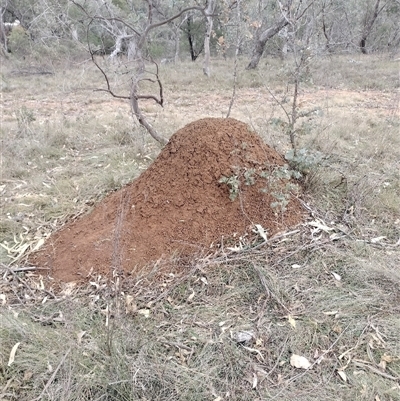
(31, 118, 304, 281)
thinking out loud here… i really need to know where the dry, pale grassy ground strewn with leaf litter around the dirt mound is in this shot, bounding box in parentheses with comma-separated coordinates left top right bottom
(0, 56, 400, 401)
